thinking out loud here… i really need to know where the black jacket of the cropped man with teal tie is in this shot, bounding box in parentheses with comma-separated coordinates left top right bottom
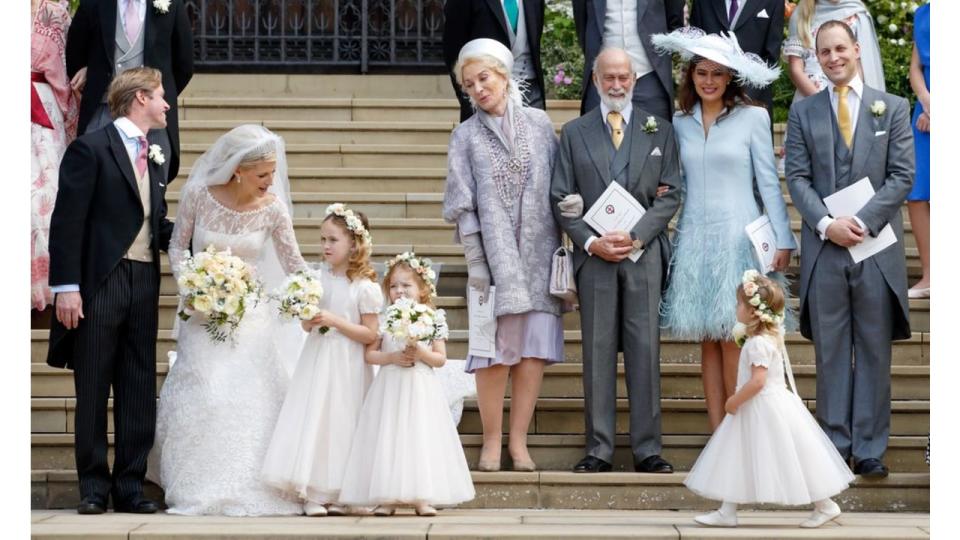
(443, 0, 546, 122)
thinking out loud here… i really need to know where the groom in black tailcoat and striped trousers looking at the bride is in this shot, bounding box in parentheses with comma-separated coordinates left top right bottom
(47, 68, 173, 514)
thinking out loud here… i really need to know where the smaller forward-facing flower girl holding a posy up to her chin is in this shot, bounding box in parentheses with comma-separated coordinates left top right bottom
(340, 252, 474, 516)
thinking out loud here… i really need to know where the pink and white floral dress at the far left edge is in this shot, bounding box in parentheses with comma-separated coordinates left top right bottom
(30, 0, 78, 310)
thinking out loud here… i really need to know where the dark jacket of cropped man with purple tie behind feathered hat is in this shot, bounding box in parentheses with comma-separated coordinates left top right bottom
(690, 0, 783, 112)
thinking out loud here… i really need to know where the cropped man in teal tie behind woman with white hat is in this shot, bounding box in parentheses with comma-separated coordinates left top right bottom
(443, 0, 547, 122)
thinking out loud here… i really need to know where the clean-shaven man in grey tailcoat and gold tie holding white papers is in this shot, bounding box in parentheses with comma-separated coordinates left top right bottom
(786, 21, 914, 478)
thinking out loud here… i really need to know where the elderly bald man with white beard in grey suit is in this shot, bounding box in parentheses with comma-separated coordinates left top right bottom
(550, 48, 680, 473)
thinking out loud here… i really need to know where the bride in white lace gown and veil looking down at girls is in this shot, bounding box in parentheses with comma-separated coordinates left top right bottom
(151, 125, 306, 516)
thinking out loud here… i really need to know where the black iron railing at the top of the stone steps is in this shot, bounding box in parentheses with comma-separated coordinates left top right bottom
(185, 0, 444, 73)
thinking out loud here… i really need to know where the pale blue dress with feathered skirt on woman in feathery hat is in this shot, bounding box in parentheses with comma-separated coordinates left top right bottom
(660, 103, 797, 341)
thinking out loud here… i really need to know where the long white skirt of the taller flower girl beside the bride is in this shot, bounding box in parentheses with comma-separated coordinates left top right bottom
(261, 330, 374, 503)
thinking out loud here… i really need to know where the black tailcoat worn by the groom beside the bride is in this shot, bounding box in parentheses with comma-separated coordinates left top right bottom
(47, 124, 173, 368)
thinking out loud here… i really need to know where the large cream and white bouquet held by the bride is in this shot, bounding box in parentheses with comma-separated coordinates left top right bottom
(177, 245, 262, 343)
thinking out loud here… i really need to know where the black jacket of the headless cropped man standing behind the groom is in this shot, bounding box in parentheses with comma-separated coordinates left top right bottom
(66, 0, 193, 181)
